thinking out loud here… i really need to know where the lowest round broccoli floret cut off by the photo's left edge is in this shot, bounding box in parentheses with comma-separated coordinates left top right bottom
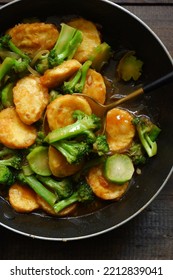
(0, 165, 15, 186)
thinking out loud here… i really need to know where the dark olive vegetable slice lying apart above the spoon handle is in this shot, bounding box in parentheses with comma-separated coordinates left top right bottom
(117, 52, 143, 82)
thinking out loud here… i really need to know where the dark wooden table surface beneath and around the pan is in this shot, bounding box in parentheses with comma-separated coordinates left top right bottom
(0, 0, 173, 260)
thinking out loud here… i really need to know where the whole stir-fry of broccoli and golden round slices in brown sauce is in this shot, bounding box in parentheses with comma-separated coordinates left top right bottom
(0, 17, 160, 217)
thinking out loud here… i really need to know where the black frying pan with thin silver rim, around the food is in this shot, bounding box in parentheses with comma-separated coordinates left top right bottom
(0, 0, 173, 240)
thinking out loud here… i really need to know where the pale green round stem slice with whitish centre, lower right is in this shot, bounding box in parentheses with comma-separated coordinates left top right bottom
(104, 154, 134, 185)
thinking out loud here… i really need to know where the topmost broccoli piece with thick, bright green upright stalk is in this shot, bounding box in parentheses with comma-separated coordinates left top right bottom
(48, 23, 83, 67)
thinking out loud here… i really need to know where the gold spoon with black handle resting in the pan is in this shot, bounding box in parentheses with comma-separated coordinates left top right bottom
(75, 71, 173, 117)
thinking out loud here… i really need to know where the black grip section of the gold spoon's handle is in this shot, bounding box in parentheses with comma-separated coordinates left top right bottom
(143, 71, 173, 93)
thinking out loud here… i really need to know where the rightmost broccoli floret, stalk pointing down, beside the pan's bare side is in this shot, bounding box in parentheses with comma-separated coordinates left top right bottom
(132, 117, 161, 157)
